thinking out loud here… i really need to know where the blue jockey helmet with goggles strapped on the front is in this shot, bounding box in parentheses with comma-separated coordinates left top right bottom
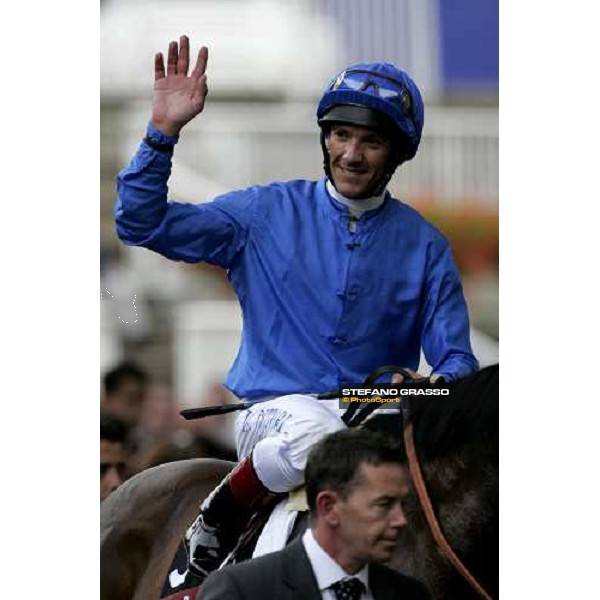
(317, 62, 424, 164)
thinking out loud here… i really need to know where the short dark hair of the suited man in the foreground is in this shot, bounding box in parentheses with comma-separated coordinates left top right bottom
(305, 429, 403, 513)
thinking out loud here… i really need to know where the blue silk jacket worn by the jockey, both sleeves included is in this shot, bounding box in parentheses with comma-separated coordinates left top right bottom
(115, 126, 478, 400)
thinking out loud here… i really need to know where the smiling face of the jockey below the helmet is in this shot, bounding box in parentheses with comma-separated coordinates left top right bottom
(325, 123, 390, 200)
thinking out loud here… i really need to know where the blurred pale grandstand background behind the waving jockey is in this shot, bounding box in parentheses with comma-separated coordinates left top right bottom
(101, 0, 498, 422)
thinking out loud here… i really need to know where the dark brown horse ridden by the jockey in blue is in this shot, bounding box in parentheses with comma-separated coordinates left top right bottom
(100, 365, 499, 600)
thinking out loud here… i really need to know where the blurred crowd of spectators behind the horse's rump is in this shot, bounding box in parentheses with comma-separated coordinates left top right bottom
(100, 362, 236, 500)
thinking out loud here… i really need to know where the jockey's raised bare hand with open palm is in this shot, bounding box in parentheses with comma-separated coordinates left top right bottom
(152, 35, 208, 135)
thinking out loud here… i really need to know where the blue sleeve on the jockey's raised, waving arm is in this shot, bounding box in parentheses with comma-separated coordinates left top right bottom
(114, 126, 256, 268)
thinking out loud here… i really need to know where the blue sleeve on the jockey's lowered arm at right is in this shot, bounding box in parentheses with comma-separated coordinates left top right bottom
(421, 238, 479, 381)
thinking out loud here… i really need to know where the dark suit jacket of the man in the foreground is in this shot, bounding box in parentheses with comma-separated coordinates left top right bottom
(196, 538, 431, 600)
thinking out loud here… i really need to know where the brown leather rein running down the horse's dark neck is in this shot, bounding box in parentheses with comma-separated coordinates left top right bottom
(404, 420, 492, 600)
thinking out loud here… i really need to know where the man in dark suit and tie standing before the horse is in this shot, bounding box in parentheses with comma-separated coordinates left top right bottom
(196, 430, 430, 600)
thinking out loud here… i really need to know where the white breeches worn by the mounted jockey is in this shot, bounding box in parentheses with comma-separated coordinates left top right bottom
(235, 394, 346, 492)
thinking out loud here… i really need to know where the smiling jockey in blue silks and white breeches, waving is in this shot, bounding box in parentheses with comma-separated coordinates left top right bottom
(115, 36, 478, 575)
